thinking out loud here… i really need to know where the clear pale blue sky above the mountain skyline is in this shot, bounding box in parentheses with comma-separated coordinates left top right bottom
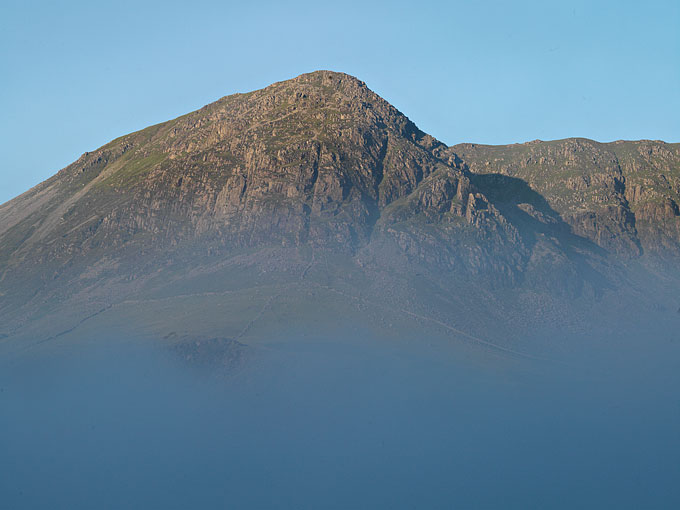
(0, 0, 680, 202)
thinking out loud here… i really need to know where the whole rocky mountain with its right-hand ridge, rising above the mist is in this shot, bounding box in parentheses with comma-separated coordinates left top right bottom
(0, 71, 680, 354)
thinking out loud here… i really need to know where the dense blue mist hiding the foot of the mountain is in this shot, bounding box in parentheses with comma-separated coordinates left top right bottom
(0, 322, 680, 509)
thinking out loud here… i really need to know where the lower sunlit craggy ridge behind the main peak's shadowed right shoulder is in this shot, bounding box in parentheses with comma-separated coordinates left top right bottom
(444, 139, 680, 261)
